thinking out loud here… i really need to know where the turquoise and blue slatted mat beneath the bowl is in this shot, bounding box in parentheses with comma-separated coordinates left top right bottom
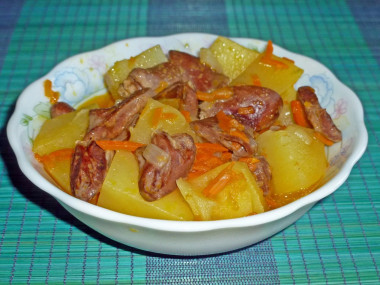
(0, 0, 380, 284)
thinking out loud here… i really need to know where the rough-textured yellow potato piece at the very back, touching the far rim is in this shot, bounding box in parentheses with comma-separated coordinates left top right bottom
(200, 37, 259, 80)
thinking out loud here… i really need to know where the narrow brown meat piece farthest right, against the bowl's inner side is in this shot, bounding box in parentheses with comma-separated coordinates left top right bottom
(297, 86, 342, 142)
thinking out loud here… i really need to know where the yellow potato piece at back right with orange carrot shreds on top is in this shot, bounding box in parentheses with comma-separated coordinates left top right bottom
(231, 54, 303, 95)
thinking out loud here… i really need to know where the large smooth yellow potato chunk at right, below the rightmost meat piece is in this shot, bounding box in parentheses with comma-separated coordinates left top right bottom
(257, 125, 328, 195)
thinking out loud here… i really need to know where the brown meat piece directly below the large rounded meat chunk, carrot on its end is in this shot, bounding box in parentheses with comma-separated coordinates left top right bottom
(190, 117, 257, 157)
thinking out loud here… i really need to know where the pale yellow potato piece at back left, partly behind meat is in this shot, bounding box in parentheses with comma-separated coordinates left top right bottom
(104, 45, 167, 100)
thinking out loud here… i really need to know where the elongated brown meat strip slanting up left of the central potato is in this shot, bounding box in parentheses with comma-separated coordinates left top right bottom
(84, 89, 154, 141)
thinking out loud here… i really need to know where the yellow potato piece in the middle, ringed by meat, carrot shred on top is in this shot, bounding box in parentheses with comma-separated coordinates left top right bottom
(130, 99, 195, 144)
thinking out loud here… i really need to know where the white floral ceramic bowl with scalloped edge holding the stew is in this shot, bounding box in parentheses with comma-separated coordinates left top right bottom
(7, 34, 368, 255)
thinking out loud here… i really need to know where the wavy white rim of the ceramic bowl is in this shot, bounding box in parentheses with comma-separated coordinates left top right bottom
(7, 33, 368, 232)
